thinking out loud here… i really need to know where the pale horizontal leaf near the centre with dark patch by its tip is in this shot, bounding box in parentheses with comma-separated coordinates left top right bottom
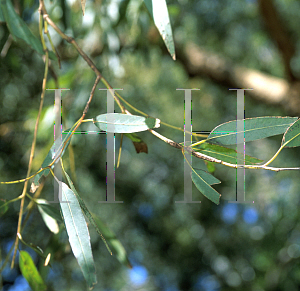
(93, 113, 160, 133)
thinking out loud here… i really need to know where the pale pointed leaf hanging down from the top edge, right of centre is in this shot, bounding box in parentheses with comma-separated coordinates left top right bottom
(144, 0, 176, 60)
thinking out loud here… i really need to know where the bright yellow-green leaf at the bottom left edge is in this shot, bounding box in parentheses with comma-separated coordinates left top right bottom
(19, 251, 47, 291)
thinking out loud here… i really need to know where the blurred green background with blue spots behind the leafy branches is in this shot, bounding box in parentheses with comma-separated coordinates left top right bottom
(0, 0, 300, 291)
